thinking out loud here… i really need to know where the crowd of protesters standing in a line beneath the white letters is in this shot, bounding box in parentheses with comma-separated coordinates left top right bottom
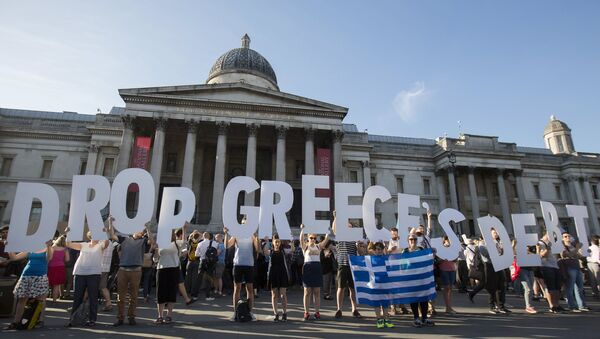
(0, 212, 600, 329)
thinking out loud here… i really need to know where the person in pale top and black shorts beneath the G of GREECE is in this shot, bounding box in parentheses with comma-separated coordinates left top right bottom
(223, 224, 259, 321)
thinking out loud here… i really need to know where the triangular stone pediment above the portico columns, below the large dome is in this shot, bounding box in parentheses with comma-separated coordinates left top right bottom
(119, 83, 348, 115)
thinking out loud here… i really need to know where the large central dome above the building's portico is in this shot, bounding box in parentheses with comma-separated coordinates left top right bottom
(206, 34, 279, 90)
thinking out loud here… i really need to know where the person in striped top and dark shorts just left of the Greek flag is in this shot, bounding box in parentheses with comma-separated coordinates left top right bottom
(331, 211, 361, 319)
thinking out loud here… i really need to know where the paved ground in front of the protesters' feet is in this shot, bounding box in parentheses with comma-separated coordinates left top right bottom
(0, 290, 600, 339)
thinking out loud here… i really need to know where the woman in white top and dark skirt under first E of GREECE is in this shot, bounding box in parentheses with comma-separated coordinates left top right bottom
(300, 224, 329, 321)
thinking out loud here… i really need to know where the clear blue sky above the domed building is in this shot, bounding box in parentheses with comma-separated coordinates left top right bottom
(0, 0, 600, 152)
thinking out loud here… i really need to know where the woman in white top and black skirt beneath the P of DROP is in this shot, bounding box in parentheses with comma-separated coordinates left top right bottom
(154, 222, 189, 325)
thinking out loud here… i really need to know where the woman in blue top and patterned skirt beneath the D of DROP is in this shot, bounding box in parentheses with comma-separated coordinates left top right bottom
(6, 240, 53, 330)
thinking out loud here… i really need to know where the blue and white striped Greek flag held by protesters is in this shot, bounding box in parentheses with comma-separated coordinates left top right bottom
(350, 248, 435, 307)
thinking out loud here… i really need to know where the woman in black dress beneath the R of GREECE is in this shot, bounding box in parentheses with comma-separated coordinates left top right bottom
(267, 235, 289, 321)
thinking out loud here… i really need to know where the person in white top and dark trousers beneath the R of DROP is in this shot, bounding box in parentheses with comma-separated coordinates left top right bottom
(65, 227, 108, 327)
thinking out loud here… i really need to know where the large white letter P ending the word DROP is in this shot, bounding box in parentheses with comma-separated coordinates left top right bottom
(156, 187, 196, 248)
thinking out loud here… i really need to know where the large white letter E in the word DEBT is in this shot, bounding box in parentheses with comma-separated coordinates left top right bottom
(512, 213, 542, 267)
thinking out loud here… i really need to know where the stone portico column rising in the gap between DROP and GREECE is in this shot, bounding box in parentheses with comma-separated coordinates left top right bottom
(209, 121, 229, 230)
